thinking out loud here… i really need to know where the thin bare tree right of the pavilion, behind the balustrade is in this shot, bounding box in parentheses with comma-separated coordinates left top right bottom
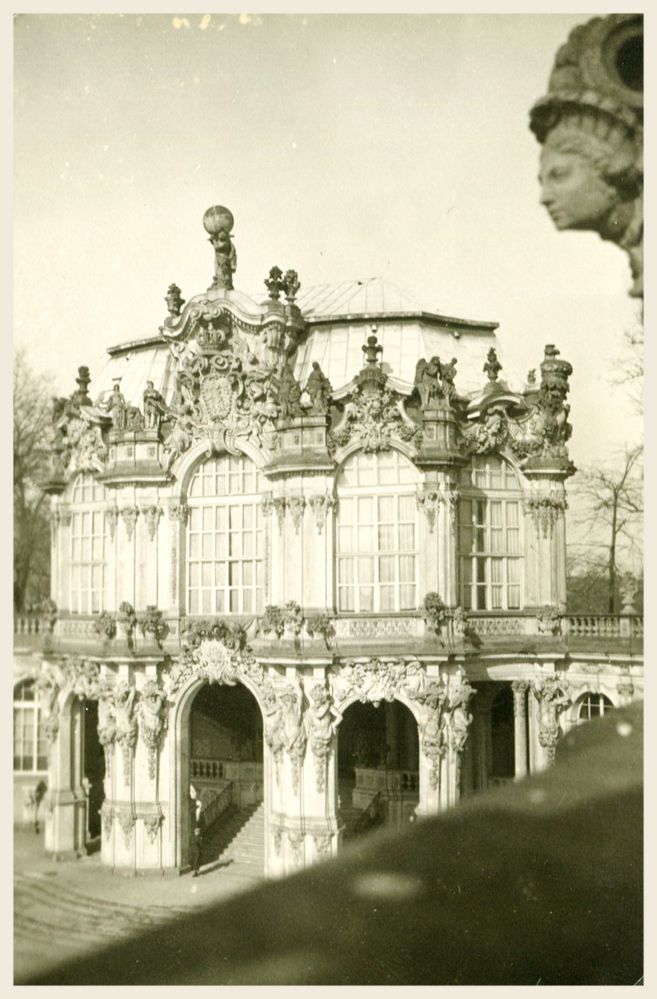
(569, 446, 643, 614)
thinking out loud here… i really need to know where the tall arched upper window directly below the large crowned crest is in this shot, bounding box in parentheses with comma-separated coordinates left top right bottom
(187, 454, 264, 614)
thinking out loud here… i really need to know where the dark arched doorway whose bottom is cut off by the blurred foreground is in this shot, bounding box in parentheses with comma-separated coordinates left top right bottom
(338, 701, 419, 840)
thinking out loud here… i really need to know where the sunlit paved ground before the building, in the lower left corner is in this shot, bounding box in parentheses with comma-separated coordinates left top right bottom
(14, 830, 261, 982)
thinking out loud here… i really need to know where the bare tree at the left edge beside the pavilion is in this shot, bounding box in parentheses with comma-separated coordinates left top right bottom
(14, 351, 52, 612)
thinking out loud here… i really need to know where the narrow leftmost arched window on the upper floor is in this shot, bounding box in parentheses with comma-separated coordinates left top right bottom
(70, 474, 107, 614)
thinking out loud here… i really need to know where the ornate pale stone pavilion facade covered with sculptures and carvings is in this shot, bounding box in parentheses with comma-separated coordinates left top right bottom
(23, 207, 642, 876)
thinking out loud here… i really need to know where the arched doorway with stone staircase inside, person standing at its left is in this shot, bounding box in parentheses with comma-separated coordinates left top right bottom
(180, 683, 264, 874)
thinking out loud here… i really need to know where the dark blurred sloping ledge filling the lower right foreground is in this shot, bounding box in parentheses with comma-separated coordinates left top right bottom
(24, 705, 643, 985)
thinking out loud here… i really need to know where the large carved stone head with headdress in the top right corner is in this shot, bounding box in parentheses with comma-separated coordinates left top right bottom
(530, 14, 643, 297)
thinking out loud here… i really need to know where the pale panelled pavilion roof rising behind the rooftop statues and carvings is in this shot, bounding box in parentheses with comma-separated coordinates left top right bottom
(94, 277, 498, 404)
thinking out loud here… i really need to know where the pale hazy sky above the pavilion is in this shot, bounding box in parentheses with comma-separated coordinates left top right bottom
(14, 14, 640, 472)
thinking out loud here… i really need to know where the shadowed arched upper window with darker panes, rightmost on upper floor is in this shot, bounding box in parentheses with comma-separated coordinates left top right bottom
(460, 455, 522, 610)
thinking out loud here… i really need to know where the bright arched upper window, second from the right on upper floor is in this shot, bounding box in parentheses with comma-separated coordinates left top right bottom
(336, 450, 418, 613)
